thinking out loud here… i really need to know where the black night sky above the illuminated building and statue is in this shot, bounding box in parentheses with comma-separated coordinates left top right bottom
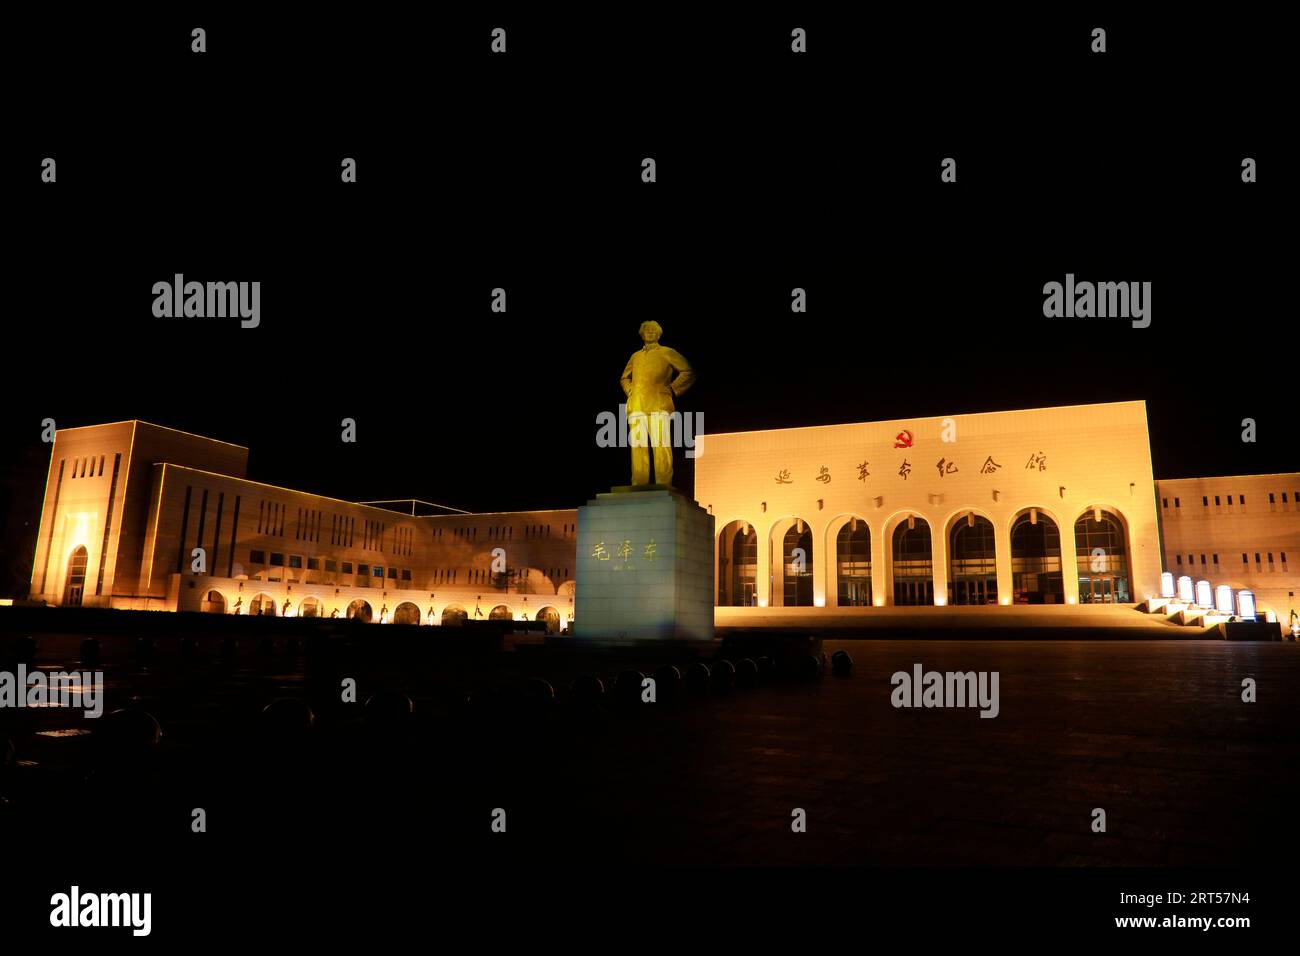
(0, 14, 1300, 598)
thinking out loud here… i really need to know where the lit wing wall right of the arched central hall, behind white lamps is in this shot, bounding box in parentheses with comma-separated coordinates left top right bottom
(1156, 472, 1300, 623)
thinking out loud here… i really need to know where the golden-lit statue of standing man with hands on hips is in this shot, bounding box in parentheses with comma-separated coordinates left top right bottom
(623, 320, 696, 485)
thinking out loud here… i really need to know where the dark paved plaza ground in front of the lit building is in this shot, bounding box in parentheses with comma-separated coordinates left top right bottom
(0, 622, 1300, 931)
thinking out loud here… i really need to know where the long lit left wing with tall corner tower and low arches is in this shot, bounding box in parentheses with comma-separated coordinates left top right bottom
(31, 421, 577, 630)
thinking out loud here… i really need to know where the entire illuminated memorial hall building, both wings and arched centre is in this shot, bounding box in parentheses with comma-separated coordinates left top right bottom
(30, 402, 1300, 632)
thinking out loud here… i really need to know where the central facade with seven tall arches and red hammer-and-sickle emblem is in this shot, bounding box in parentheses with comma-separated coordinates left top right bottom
(696, 402, 1161, 606)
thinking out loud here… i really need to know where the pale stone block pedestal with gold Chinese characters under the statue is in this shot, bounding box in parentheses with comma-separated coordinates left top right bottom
(573, 485, 714, 643)
